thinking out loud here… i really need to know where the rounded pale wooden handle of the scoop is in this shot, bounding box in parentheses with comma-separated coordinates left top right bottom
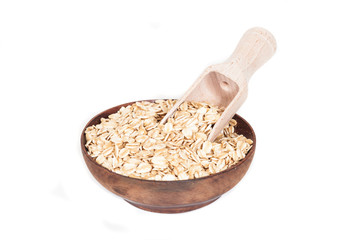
(224, 27, 276, 84)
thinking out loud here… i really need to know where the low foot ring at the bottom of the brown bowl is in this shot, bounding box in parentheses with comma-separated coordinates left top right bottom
(124, 196, 220, 213)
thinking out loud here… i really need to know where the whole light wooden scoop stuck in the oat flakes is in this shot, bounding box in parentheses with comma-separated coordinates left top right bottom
(161, 27, 276, 141)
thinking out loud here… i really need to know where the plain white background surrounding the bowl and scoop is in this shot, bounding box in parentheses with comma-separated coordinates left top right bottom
(0, 0, 360, 240)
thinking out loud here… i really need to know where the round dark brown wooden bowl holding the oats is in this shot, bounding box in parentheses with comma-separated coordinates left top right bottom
(81, 100, 256, 213)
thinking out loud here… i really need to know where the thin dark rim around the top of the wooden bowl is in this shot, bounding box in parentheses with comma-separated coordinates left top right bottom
(80, 99, 256, 184)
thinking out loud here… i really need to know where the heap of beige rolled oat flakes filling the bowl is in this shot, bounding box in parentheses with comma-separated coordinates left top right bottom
(85, 100, 253, 181)
